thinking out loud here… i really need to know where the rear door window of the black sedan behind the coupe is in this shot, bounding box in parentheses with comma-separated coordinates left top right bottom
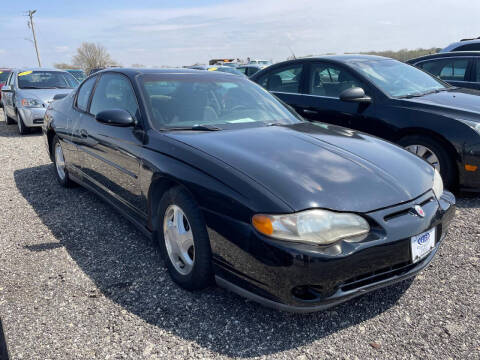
(258, 64, 303, 94)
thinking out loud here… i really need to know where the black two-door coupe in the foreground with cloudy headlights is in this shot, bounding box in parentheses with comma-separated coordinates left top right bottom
(43, 69, 455, 312)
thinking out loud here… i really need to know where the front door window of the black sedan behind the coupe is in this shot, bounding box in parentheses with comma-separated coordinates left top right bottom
(309, 63, 365, 98)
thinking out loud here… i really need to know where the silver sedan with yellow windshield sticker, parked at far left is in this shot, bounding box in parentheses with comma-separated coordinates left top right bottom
(1, 68, 79, 134)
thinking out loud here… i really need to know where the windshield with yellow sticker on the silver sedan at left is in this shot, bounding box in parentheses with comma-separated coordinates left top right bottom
(18, 71, 79, 89)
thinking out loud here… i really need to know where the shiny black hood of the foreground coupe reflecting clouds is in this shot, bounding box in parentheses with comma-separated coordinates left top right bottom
(168, 123, 433, 212)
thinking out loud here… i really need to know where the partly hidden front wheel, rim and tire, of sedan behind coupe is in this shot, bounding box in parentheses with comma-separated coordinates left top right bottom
(399, 135, 457, 189)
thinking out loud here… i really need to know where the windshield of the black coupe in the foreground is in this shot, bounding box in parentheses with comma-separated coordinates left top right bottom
(141, 74, 303, 129)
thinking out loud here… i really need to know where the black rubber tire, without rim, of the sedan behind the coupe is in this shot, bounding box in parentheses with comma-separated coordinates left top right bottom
(399, 135, 458, 190)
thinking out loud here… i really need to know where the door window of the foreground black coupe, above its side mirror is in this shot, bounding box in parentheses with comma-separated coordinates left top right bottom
(90, 73, 138, 119)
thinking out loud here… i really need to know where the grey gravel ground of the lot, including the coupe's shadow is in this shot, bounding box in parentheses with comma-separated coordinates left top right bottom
(0, 114, 480, 360)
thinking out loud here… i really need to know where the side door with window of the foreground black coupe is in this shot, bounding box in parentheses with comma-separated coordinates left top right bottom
(78, 72, 147, 217)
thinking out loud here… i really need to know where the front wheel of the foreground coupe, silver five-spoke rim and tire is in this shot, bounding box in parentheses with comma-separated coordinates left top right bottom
(156, 187, 213, 290)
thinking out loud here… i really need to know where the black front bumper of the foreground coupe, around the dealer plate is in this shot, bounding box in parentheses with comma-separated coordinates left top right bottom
(206, 191, 455, 312)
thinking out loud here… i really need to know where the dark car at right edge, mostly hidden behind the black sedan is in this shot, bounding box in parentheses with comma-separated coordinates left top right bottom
(407, 51, 480, 90)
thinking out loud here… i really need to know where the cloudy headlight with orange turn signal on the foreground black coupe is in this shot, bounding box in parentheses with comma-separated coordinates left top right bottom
(252, 209, 370, 245)
